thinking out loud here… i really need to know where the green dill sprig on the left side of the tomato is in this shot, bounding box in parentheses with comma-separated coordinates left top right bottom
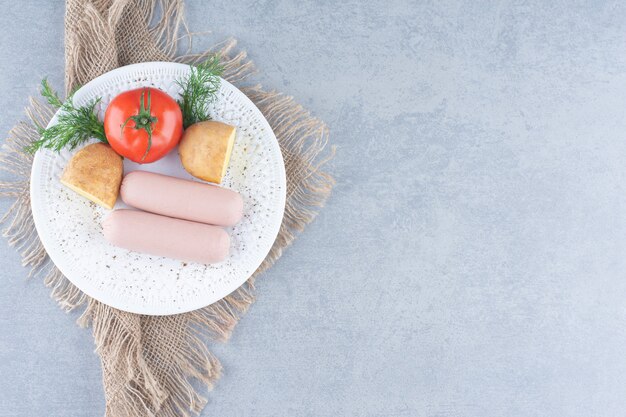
(26, 78, 108, 153)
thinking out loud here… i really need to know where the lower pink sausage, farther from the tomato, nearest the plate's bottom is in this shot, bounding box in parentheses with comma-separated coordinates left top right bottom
(102, 210, 230, 264)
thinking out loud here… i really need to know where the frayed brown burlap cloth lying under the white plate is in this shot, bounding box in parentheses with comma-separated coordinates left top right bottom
(0, 0, 333, 417)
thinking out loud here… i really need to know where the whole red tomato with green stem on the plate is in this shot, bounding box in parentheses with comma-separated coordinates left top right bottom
(104, 87, 183, 164)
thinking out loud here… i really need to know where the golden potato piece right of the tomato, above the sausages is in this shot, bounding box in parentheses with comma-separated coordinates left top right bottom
(178, 120, 237, 184)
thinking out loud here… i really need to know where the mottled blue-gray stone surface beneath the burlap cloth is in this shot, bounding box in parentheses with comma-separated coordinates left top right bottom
(0, 0, 626, 417)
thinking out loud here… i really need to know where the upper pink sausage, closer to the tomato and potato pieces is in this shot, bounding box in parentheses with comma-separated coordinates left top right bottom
(120, 171, 243, 226)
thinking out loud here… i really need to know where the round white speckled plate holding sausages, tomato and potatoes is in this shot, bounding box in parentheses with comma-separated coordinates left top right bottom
(30, 62, 286, 315)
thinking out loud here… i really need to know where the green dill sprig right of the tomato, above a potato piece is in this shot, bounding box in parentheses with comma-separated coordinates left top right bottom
(176, 55, 224, 129)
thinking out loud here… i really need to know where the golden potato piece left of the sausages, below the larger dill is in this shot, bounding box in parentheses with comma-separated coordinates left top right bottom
(61, 143, 124, 210)
